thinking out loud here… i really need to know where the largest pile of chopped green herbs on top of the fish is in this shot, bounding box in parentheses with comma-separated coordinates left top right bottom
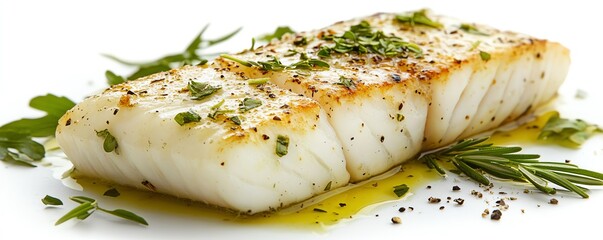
(317, 21, 422, 58)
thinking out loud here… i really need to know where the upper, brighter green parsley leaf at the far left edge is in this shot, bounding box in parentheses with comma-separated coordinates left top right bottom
(0, 94, 75, 137)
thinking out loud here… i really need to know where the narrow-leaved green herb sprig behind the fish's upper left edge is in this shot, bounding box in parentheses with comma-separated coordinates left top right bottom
(103, 25, 241, 85)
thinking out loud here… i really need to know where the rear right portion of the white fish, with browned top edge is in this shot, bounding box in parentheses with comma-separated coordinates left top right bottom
(226, 10, 569, 181)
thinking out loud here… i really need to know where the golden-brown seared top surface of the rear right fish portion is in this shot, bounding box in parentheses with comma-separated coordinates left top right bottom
(230, 13, 561, 103)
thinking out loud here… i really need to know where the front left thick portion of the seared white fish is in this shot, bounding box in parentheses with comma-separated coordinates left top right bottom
(57, 66, 349, 213)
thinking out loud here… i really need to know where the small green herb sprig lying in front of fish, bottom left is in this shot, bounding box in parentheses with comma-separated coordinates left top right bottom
(55, 196, 149, 226)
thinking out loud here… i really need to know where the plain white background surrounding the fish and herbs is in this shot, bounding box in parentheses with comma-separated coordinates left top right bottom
(0, 0, 603, 239)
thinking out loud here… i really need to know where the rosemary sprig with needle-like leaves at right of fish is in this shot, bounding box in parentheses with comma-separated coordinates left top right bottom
(419, 137, 603, 198)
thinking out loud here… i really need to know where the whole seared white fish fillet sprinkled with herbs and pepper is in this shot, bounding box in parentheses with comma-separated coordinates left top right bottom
(57, 10, 570, 213)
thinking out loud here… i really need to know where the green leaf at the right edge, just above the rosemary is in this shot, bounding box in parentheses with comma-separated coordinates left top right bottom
(538, 112, 603, 147)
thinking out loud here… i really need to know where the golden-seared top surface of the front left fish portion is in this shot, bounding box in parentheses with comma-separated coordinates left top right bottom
(59, 64, 320, 141)
